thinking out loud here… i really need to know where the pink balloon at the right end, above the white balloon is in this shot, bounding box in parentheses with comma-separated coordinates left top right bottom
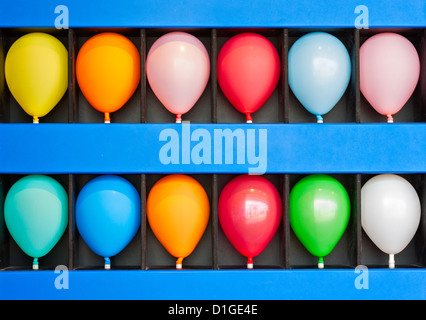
(359, 33, 420, 122)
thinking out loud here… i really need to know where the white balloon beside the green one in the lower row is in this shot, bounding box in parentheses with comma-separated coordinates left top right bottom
(361, 174, 421, 268)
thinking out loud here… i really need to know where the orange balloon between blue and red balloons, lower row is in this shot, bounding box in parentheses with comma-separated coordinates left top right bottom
(146, 174, 210, 269)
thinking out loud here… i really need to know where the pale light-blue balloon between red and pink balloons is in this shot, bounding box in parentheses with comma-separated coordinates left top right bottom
(288, 32, 351, 122)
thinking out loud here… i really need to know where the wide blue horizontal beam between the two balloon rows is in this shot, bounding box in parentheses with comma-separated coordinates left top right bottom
(0, 123, 426, 174)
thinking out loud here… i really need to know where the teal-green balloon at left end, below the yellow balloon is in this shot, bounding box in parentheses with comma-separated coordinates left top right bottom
(4, 175, 68, 268)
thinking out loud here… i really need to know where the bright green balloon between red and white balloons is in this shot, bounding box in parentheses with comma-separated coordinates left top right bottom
(289, 174, 351, 268)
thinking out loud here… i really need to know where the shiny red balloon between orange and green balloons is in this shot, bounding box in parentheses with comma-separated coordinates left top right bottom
(218, 175, 282, 268)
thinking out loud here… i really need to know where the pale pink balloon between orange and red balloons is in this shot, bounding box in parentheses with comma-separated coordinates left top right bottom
(146, 32, 210, 123)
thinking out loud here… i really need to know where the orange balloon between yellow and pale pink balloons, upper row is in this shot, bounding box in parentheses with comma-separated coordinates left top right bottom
(76, 32, 140, 123)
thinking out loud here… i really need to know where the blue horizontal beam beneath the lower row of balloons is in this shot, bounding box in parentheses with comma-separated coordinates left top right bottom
(0, 269, 426, 300)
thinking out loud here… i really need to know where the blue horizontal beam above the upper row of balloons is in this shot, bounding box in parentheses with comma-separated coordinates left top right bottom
(0, 0, 426, 28)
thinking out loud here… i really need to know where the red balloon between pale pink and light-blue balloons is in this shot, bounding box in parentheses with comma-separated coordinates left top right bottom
(217, 33, 280, 123)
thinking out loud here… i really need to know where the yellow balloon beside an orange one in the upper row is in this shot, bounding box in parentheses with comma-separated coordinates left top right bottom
(5, 32, 68, 123)
